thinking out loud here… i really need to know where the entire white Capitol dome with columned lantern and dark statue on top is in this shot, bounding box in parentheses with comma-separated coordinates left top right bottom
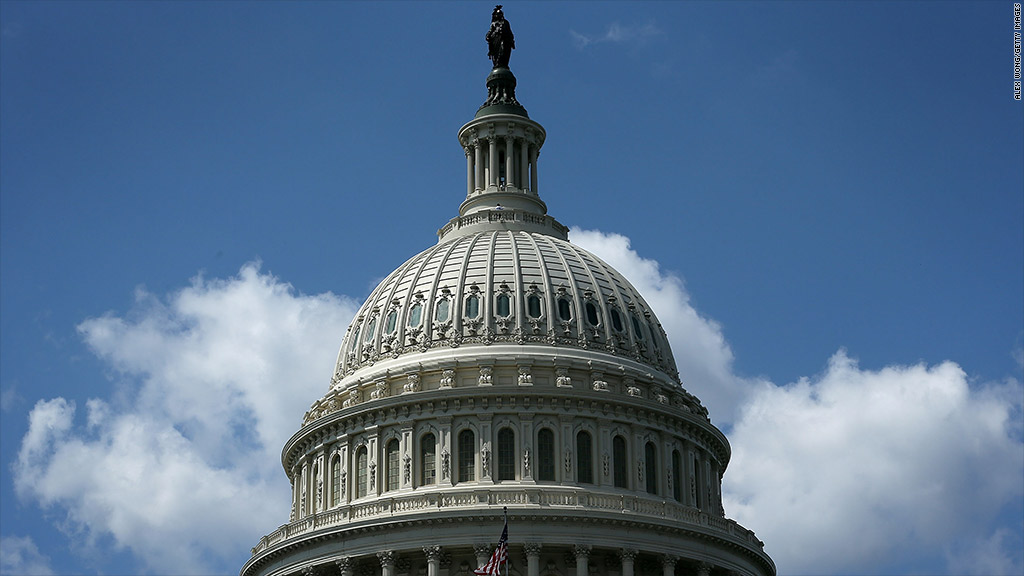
(241, 6, 775, 576)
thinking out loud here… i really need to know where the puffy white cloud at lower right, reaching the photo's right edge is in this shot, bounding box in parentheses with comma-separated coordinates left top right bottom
(725, 351, 1024, 574)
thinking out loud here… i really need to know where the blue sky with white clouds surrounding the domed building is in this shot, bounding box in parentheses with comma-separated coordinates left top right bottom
(0, 0, 1024, 574)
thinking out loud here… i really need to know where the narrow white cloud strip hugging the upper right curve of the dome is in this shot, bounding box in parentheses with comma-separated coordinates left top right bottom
(569, 228, 761, 422)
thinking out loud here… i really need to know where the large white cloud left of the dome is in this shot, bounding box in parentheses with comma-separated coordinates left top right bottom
(13, 264, 355, 574)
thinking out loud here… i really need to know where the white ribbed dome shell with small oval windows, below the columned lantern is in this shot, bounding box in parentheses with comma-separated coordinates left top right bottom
(334, 229, 678, 387)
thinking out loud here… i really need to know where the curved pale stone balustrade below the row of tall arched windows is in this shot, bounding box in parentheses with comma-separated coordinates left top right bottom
(252, 486, 764, 557)
